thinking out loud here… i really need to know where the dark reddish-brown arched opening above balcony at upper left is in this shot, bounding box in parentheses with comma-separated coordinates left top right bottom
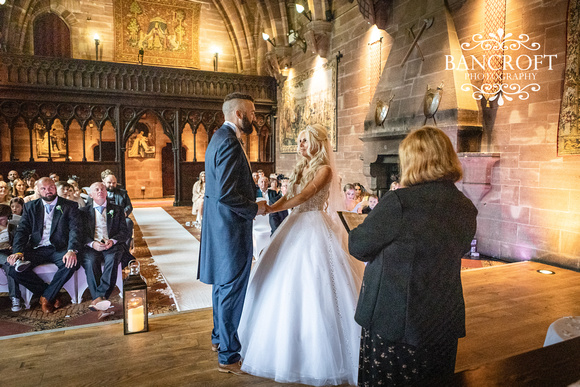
(34, 13, 71, 58)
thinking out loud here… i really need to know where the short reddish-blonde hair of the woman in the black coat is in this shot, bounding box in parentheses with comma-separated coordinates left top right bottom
(399, 126, 463, 187)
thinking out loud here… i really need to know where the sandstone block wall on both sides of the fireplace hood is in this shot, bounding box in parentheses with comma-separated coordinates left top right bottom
(276, 0, 580, 270)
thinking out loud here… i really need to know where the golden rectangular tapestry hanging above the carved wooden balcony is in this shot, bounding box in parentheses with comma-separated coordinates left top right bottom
(114, 0, 201, 68)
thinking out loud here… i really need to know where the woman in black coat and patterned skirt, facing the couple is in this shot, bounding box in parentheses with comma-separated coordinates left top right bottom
(349, 127, 477, 386)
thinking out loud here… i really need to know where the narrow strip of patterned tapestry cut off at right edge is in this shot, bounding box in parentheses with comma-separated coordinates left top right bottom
(558, 0, 580, 156)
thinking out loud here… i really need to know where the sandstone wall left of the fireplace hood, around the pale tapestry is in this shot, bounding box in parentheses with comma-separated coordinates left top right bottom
(276, 0, 391, 188)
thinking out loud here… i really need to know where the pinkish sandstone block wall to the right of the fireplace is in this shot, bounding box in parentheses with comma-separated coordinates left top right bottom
(454, 0, 580, 270)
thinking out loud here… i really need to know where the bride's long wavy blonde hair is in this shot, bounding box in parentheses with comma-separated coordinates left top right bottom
(286, 124, 330, 199)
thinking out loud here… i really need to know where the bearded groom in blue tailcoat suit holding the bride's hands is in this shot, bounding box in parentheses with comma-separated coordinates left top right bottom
(198, 93, 267, 374)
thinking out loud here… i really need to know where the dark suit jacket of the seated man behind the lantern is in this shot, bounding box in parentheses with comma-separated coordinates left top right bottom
(79, 202, 129, 246)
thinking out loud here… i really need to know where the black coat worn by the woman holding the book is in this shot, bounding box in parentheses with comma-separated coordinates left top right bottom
(349, 182, 477, 346)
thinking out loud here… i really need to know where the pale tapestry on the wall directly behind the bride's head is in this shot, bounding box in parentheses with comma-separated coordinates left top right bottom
(279, 63, 336, 153)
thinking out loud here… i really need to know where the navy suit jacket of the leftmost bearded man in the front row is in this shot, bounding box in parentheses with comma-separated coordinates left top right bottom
(12, 196, 81, 253)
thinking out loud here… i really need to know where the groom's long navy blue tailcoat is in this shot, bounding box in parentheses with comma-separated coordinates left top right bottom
(198, 125, 258, 285)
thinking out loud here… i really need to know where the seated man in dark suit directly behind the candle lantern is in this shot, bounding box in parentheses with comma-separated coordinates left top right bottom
(80, 182, 129, 318)
